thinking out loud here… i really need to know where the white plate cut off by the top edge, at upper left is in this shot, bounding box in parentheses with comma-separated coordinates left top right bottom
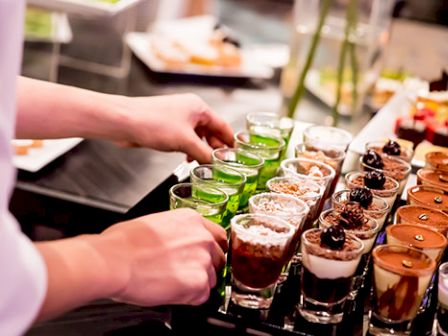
(27, 0, 141, 15)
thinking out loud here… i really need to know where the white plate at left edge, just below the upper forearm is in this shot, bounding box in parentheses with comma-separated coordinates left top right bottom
(13, 138, 83, 173)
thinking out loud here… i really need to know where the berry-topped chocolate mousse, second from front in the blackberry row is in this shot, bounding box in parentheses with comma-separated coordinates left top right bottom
(319, 202, 379, 254)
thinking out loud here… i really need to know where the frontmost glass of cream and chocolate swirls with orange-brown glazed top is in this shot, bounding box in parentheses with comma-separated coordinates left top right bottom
(369, 245, 436, 335)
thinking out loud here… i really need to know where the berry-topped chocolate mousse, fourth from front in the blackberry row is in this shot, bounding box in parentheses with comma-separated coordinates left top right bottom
(345, 170, 399, 211)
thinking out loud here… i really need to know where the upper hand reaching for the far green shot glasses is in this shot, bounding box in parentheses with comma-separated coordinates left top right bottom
(115, 94, 233, 163)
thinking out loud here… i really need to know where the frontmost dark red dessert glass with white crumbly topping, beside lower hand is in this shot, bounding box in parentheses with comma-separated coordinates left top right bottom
(230, 214, 296, 309)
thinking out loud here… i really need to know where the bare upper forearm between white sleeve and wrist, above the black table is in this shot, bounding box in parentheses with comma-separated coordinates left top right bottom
(16, 77, 129, 140)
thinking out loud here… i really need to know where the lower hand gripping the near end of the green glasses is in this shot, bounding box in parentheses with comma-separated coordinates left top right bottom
(95, 209, 227, 306)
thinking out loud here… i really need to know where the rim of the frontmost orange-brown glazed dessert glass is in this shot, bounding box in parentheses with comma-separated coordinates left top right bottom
(372, 244, 436, 276)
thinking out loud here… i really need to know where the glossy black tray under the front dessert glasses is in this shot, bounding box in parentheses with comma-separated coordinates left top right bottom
(172, 203, 437, 336)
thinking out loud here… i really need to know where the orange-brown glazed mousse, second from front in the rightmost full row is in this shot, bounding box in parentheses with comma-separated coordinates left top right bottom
(386, 224, 447, 262)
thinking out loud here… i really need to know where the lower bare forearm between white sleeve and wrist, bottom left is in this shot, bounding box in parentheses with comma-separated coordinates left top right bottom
(36, 235, 128, 321)
